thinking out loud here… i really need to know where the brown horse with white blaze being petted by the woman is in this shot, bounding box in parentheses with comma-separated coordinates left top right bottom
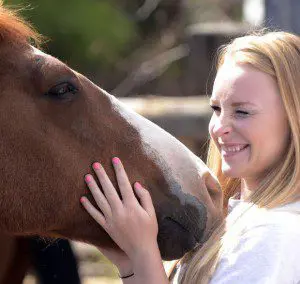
(0, 1, 222, 283)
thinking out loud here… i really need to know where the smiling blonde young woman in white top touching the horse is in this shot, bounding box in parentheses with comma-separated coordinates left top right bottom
(81, 32, 300, 284)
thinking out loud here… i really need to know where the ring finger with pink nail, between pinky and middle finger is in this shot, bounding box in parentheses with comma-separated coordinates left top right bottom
(85, 174, 111, 217)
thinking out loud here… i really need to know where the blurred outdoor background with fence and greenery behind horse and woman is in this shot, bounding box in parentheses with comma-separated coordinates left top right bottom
(5, 0, 300, 284)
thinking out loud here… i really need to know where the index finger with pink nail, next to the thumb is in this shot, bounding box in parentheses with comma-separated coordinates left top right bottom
(112, 157, 137, 202)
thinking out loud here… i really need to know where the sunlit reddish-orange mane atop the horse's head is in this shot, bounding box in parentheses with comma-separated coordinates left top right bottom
(0, 0, 43, 46)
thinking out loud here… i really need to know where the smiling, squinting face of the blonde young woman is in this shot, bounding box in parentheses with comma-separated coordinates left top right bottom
(209, 61, 289, 184)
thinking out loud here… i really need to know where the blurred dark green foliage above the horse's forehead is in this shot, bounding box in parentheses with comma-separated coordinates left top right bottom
(5, 0, 137, 70)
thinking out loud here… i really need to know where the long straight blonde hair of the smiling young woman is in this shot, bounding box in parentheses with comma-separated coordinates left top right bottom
(176, 31, 300, 284)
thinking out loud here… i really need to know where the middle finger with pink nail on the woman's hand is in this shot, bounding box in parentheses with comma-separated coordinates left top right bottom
(93, 162, 123, 210)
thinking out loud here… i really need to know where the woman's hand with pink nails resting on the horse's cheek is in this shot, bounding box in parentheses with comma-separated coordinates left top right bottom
(81, 155, 158, 265)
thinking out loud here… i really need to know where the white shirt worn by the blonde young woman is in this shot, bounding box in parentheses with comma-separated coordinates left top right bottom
(172, 199, 300, 284)
